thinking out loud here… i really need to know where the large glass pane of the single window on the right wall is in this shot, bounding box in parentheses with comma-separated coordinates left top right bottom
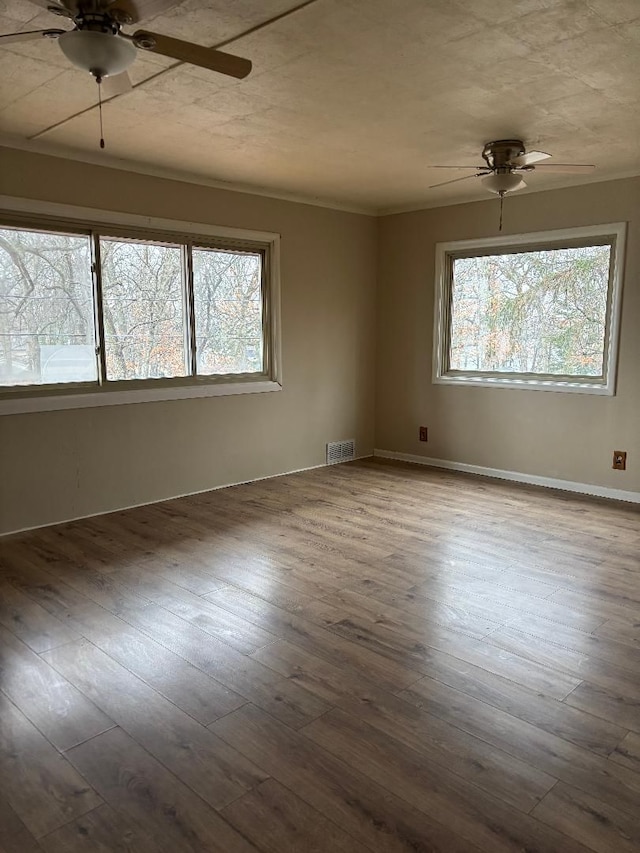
(449, 245, 611, 376)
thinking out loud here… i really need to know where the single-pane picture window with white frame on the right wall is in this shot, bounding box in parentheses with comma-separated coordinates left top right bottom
(434, 223, 625, 394)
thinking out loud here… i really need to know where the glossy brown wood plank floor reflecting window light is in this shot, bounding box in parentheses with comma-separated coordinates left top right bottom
(0, 460, 640, 853)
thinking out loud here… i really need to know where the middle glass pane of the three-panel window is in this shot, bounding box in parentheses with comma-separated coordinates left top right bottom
(100, 239, 188, 380)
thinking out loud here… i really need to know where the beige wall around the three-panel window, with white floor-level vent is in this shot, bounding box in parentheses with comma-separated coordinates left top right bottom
(0, 149, 376, 532)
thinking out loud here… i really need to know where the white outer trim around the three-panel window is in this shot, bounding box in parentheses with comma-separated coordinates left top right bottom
(0, 195, 282, 416)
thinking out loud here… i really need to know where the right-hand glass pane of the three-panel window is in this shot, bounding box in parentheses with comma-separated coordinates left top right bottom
(193, 249, 264, 375)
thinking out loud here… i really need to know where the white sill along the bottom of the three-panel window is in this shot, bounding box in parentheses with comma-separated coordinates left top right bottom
(0, 379, 282, 416)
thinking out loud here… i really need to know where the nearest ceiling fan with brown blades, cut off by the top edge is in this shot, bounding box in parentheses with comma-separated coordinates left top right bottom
(0, 0, 251, 94)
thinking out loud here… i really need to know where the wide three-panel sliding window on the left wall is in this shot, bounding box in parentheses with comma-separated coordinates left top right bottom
(0, 205, 278, 411)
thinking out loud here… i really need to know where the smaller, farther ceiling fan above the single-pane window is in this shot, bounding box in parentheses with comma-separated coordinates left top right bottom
(429, 139, 595, 197)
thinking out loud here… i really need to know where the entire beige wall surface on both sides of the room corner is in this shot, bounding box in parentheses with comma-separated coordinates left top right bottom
(0, 149, 640, 532)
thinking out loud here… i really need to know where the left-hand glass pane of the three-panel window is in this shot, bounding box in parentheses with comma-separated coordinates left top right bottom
(0, 228, 98, 386)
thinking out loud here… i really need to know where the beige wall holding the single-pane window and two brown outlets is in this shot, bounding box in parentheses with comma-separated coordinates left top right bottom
(376, 178, 640, 492)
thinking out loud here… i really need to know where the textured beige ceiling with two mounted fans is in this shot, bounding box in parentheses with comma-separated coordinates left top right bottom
(0, 0, 640, 211)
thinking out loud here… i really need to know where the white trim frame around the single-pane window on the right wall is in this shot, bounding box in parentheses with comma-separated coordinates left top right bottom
(433, 222, 627, 396)
